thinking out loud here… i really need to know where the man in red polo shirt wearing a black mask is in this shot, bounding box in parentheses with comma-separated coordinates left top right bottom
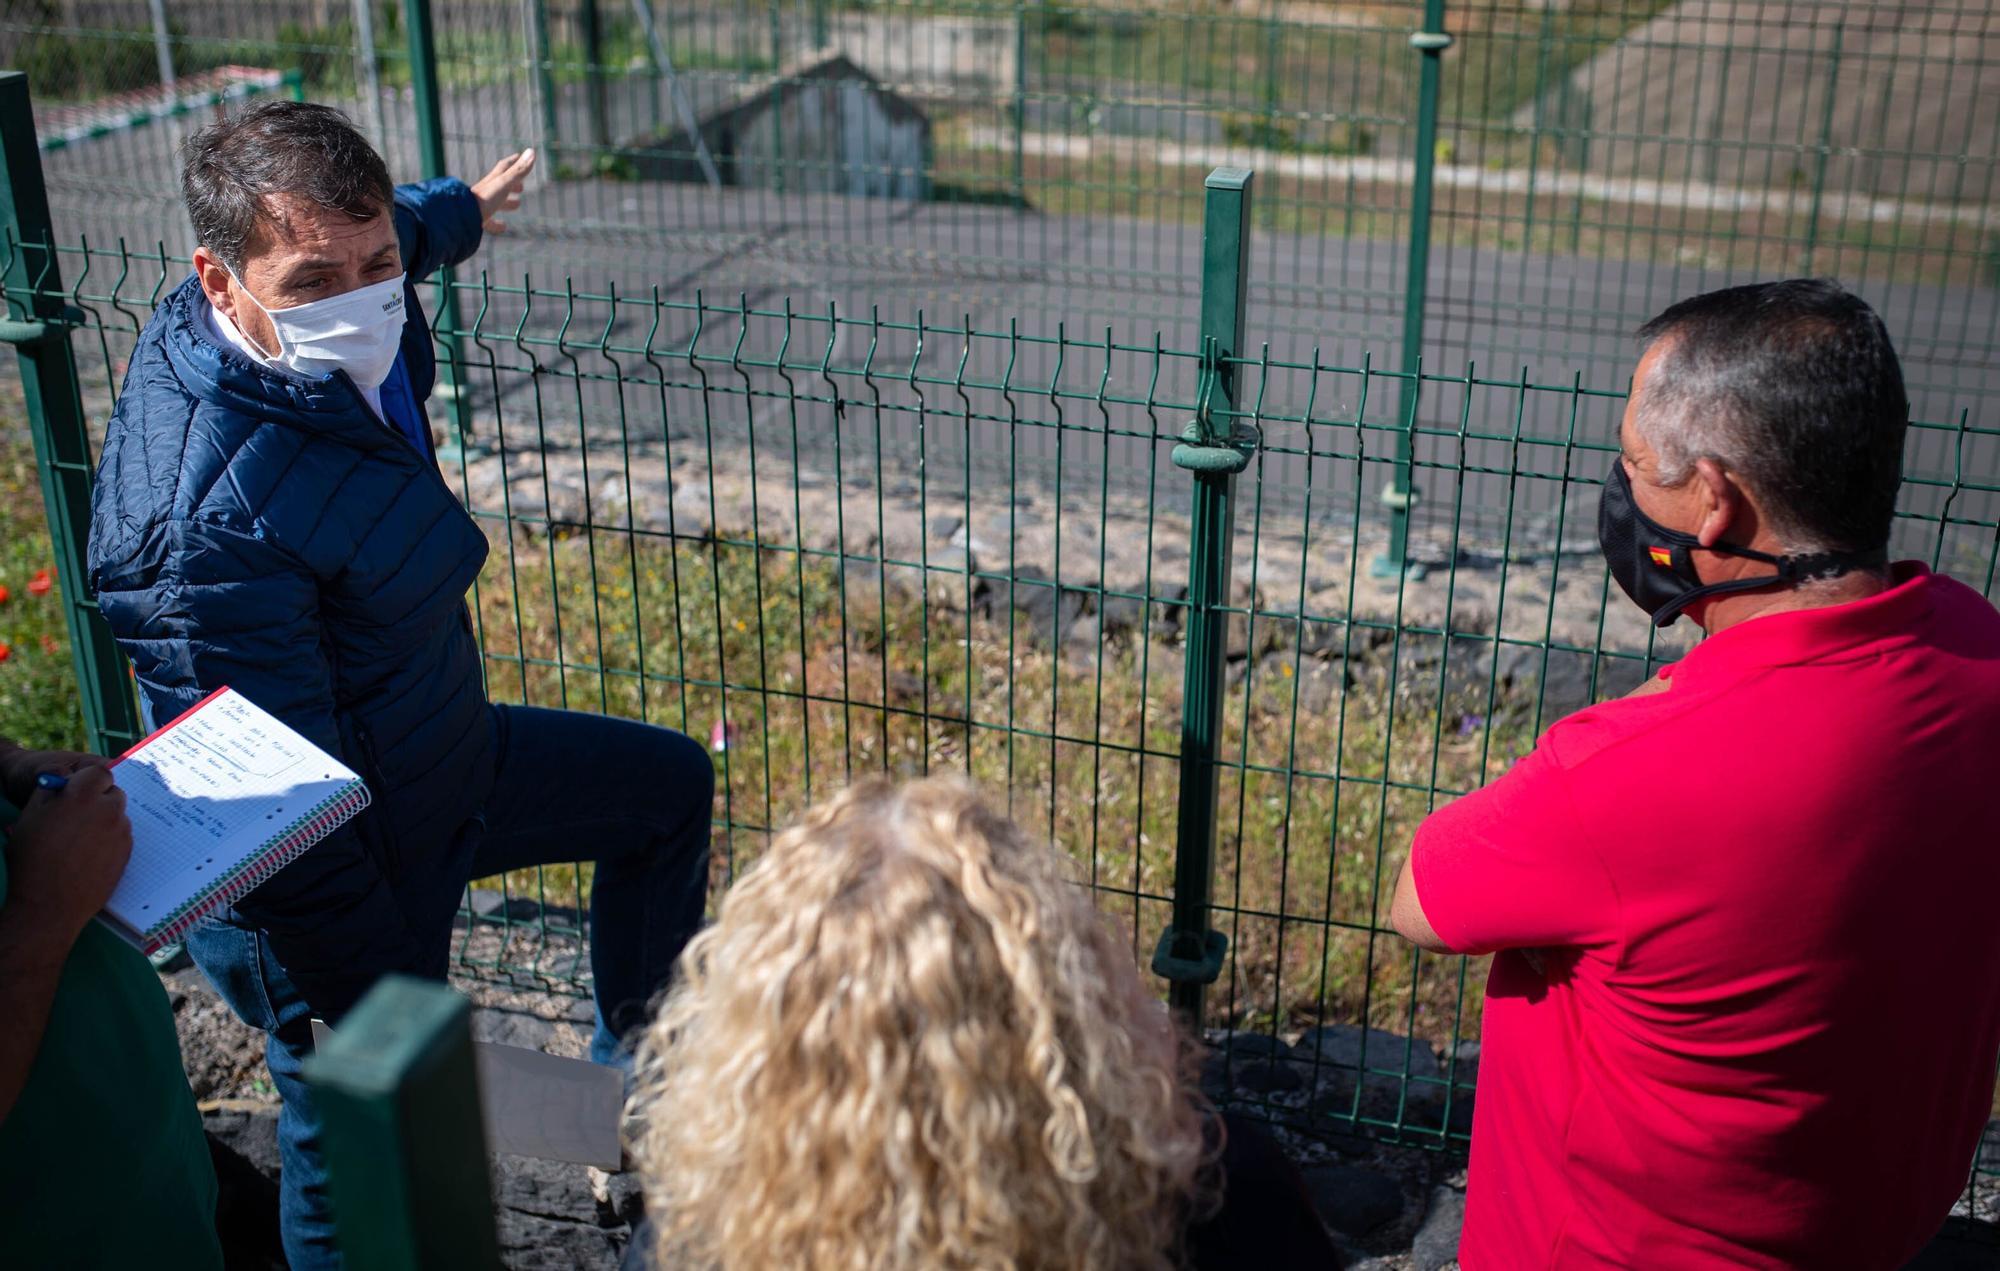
(1394, 280, 2000, 1271)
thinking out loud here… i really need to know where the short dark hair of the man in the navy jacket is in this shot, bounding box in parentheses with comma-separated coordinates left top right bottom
(180, 102, 396, 274)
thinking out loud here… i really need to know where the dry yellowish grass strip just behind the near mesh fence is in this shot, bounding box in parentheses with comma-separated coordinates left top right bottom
(460, 519, 1528, 1043)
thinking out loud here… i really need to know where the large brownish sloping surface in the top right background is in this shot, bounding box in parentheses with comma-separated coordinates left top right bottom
(1512, 0, 2000, 202)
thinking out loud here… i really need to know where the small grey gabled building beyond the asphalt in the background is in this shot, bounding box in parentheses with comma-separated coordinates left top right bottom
(628, 52, 930, 200)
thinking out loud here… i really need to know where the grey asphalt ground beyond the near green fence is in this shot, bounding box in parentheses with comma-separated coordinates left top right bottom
(31, 71, 2000, 563)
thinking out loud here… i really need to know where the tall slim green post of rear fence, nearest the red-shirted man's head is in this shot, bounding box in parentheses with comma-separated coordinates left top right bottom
(1368, 0, 1452, 578)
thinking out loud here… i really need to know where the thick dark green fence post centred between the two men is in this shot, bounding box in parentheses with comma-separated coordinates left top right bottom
(1152, 168, 1256, 1027)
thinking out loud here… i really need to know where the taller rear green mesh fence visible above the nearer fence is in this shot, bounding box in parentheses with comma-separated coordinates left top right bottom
(15, 0, 2000, 562)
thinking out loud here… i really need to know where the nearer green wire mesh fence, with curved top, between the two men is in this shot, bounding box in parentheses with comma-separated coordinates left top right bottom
(8, 223, 2000, 1143)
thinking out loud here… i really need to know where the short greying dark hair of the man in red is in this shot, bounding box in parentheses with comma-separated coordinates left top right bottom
(1634, 278, 1910, 552)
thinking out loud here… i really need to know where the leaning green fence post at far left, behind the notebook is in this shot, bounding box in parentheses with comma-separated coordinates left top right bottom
(0, 70, 142, 755)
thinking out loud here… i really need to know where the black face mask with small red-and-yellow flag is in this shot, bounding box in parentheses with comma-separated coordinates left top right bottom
(1598, 460, 1888, 628)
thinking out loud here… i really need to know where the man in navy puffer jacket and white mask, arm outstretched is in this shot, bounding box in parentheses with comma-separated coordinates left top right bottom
(90, 102, 714, 1269)
